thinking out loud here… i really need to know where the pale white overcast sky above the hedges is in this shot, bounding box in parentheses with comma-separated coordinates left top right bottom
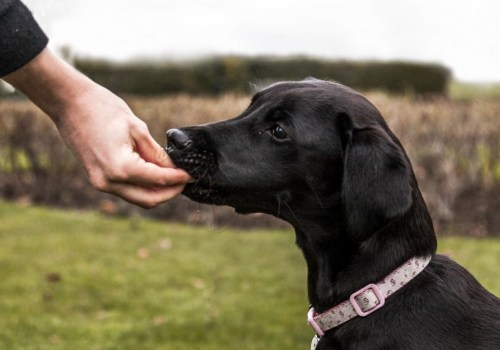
(24, 0, 500, 82)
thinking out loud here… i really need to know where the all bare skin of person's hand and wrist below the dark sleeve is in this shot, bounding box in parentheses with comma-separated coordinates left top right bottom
(4, 49, 190, 208)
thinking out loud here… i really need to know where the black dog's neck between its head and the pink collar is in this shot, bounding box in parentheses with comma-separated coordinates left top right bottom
(293, 194, 436, 312)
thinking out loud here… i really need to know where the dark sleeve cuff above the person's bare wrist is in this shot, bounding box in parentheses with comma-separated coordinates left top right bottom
(0, 0, 48, 77)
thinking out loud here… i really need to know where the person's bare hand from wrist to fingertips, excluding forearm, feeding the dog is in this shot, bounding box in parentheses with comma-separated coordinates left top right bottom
(56, 84, 190, 208)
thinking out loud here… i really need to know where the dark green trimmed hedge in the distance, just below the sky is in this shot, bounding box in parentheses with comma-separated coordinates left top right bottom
(75, 56, 451, 95)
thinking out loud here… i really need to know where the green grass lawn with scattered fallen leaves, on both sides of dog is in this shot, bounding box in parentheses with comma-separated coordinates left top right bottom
(0, 202, 500, 350)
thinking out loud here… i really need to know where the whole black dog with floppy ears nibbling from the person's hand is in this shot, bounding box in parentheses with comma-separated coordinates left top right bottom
(167, 80, 500, 350)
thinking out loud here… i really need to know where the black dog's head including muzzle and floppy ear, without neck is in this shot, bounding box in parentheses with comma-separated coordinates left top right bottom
(166, 80, 416, 240)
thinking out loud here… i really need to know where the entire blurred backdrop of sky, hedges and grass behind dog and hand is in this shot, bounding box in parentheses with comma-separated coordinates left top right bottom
(0, 0, 500, 349)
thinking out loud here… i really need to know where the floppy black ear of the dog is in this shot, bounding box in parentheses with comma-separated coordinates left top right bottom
(338, 114, 412, 242)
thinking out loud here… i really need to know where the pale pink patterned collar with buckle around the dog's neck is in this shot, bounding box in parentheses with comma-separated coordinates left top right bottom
(307, 256, 432, 337)
